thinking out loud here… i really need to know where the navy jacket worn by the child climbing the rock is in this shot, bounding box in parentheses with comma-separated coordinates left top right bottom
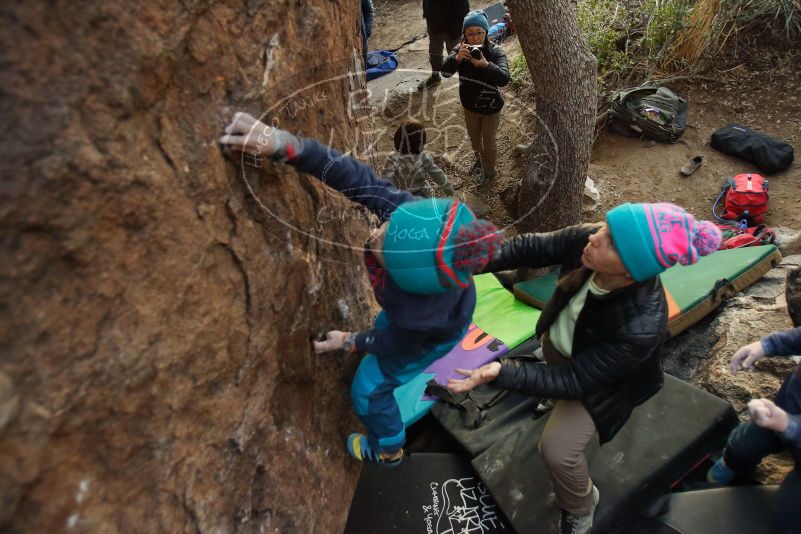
(290, 139, 476, 356)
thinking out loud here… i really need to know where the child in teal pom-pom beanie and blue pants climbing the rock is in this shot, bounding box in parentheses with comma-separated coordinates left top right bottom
(220, 113, 501, 465)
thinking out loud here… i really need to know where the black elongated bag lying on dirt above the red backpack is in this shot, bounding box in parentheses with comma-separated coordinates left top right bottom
(710, 124, 793, 174)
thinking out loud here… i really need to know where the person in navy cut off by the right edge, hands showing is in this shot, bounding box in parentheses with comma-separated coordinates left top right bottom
(707, 327, 801, 534)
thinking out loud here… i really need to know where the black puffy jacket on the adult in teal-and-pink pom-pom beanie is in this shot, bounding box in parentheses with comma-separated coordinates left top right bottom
(486, 224, 668, 443)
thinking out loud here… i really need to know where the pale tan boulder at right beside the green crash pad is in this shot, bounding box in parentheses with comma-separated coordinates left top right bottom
(665, 255, 801, 483)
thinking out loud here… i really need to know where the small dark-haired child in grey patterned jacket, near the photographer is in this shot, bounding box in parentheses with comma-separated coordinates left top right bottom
(382, 119, 456, 197)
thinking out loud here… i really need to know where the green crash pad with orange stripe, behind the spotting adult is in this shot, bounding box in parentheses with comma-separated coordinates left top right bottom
(514, 245, 782, 336)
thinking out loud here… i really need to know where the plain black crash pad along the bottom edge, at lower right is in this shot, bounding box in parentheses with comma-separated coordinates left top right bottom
(625, 486, 779, 534)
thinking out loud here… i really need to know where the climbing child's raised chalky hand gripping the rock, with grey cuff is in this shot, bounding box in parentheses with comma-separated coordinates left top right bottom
(219, 111, 300, 160)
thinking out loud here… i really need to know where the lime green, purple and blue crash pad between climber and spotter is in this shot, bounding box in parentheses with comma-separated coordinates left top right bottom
(395, 274, 540, 426)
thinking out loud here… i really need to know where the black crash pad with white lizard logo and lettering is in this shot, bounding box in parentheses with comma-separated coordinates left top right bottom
(345, 453, 511, 534)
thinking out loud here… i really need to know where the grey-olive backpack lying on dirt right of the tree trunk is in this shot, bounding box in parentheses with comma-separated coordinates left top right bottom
(606, 86, 687, 143)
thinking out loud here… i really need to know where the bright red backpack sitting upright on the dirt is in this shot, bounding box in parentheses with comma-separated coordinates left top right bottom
(712, 173, 768, 227)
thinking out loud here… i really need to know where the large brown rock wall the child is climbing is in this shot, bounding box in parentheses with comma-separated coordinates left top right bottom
(0, 0, 382, 533)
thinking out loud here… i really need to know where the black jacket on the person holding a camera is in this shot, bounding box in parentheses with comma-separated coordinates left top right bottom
(440, 38, 509, 115)
